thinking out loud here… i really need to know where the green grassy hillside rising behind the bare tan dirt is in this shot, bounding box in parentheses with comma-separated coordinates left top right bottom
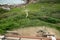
(0, 3, 60, 34)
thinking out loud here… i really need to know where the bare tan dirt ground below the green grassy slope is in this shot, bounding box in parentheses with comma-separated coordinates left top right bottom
(13, 27, 60, 37)
